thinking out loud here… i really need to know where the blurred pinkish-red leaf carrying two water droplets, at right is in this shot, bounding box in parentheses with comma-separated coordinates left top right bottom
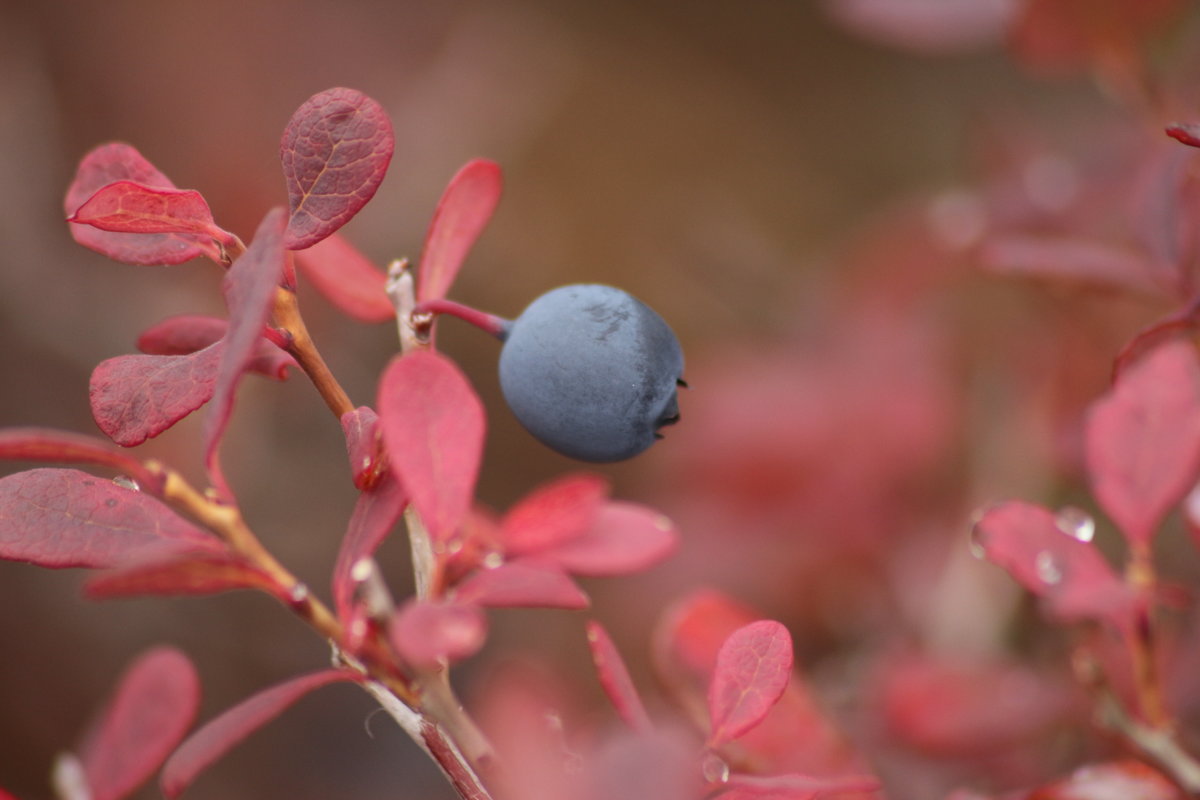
(971, 501, 1135, 627)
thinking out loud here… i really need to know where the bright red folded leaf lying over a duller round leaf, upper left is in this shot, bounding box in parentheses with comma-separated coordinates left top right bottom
(67, 181, 236, 246)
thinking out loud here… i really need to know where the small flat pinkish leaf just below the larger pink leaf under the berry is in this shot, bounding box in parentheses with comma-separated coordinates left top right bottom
(455, 559, 589, 608)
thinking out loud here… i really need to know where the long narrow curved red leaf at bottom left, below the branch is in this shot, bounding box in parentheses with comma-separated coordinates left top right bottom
(160, 669, 362, 798)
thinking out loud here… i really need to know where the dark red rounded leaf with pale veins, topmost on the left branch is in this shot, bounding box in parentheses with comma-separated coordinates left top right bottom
(280, 89, 396, 249)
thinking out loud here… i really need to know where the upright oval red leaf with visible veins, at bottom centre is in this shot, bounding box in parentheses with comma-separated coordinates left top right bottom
(708, 620, 792, 747)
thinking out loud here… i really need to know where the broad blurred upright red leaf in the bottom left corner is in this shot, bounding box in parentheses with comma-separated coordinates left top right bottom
(79, 648, 200, 800)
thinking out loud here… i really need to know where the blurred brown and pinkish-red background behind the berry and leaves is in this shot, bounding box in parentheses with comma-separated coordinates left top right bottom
(0, 0, 1200, 800)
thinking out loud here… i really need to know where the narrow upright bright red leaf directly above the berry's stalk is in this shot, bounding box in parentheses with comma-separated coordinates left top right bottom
(416, 158, 503, 302)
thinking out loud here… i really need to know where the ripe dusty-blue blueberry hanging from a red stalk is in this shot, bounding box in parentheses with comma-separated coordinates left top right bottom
(500, 284, 683, 462)
